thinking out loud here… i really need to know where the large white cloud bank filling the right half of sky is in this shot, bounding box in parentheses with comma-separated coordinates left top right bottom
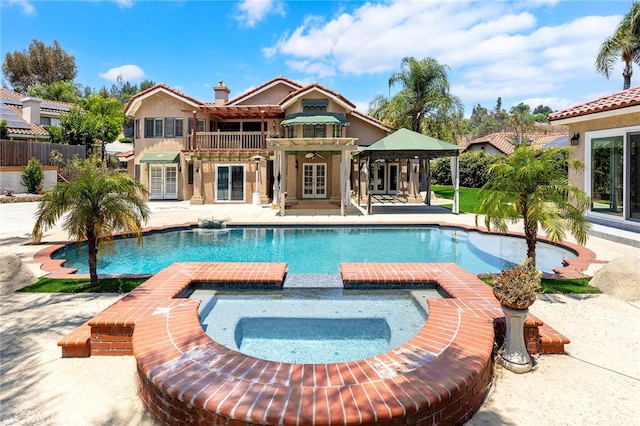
(263, 0, 621, 108)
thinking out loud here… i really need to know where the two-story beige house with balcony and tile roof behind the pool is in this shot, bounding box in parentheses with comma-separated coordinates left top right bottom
(125, 77, 392, 210)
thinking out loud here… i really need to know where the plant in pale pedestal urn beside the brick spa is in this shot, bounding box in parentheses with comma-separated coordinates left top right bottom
(493, 259, 541, 373)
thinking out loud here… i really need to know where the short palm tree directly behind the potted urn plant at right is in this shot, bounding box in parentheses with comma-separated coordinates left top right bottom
(476, 146, 589, 265)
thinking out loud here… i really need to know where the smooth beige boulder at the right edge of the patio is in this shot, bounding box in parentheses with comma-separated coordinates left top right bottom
(589, 256, 640, 301)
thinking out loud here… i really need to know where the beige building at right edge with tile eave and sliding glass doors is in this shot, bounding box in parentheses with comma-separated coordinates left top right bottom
(549, 86, 640, 232)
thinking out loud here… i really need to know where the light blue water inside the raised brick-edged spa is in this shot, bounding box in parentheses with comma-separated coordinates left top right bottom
(190, 288, 441, 364)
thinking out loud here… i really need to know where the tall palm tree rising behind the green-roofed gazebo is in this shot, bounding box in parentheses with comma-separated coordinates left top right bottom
(389, 57, 463, 133)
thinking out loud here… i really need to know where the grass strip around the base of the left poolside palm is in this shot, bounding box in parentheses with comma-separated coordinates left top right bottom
(18, 277, 148, 293)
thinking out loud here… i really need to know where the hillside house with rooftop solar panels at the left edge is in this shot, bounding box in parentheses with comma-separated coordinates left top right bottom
(0, 88, 73, 142)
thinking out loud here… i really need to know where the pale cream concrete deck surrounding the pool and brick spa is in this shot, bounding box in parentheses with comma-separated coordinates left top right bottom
(0, 202, 640, 425)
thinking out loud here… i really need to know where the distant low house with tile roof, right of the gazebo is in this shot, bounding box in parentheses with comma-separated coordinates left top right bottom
(467, 132, 569, 155)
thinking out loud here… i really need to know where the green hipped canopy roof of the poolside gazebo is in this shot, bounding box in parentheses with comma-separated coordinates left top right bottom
(358, 129, 464, 159)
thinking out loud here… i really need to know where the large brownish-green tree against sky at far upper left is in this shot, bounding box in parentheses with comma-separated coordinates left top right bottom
(2, 39, 78, 93)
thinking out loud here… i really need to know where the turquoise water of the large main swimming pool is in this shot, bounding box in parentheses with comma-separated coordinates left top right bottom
(52, 226, 575, 274)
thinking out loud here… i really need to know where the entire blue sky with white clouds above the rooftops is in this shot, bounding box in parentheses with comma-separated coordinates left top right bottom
(0, 0, 640, 116)
